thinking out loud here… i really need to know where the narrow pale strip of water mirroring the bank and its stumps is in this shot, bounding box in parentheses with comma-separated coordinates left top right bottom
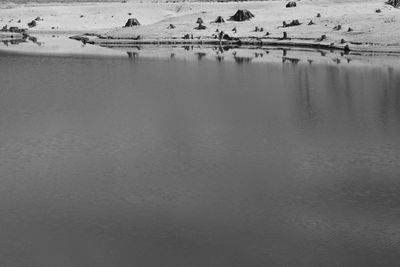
(0, 35, 400, 69)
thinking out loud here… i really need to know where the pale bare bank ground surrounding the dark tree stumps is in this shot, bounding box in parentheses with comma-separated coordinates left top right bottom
(0, 0, 400, 55)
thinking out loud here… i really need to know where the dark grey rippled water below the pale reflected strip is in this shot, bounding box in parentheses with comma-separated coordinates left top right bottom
(0, 55, 400, 267)
